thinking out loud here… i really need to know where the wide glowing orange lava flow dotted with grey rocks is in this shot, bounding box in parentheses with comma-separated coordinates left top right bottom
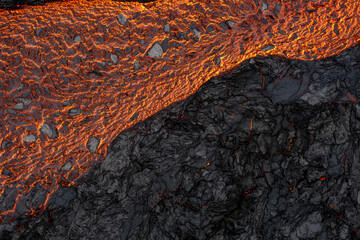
(0, 0, 360, 220)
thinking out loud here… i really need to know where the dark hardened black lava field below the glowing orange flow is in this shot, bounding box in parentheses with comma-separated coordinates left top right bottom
(0, 46, 360, 240)
